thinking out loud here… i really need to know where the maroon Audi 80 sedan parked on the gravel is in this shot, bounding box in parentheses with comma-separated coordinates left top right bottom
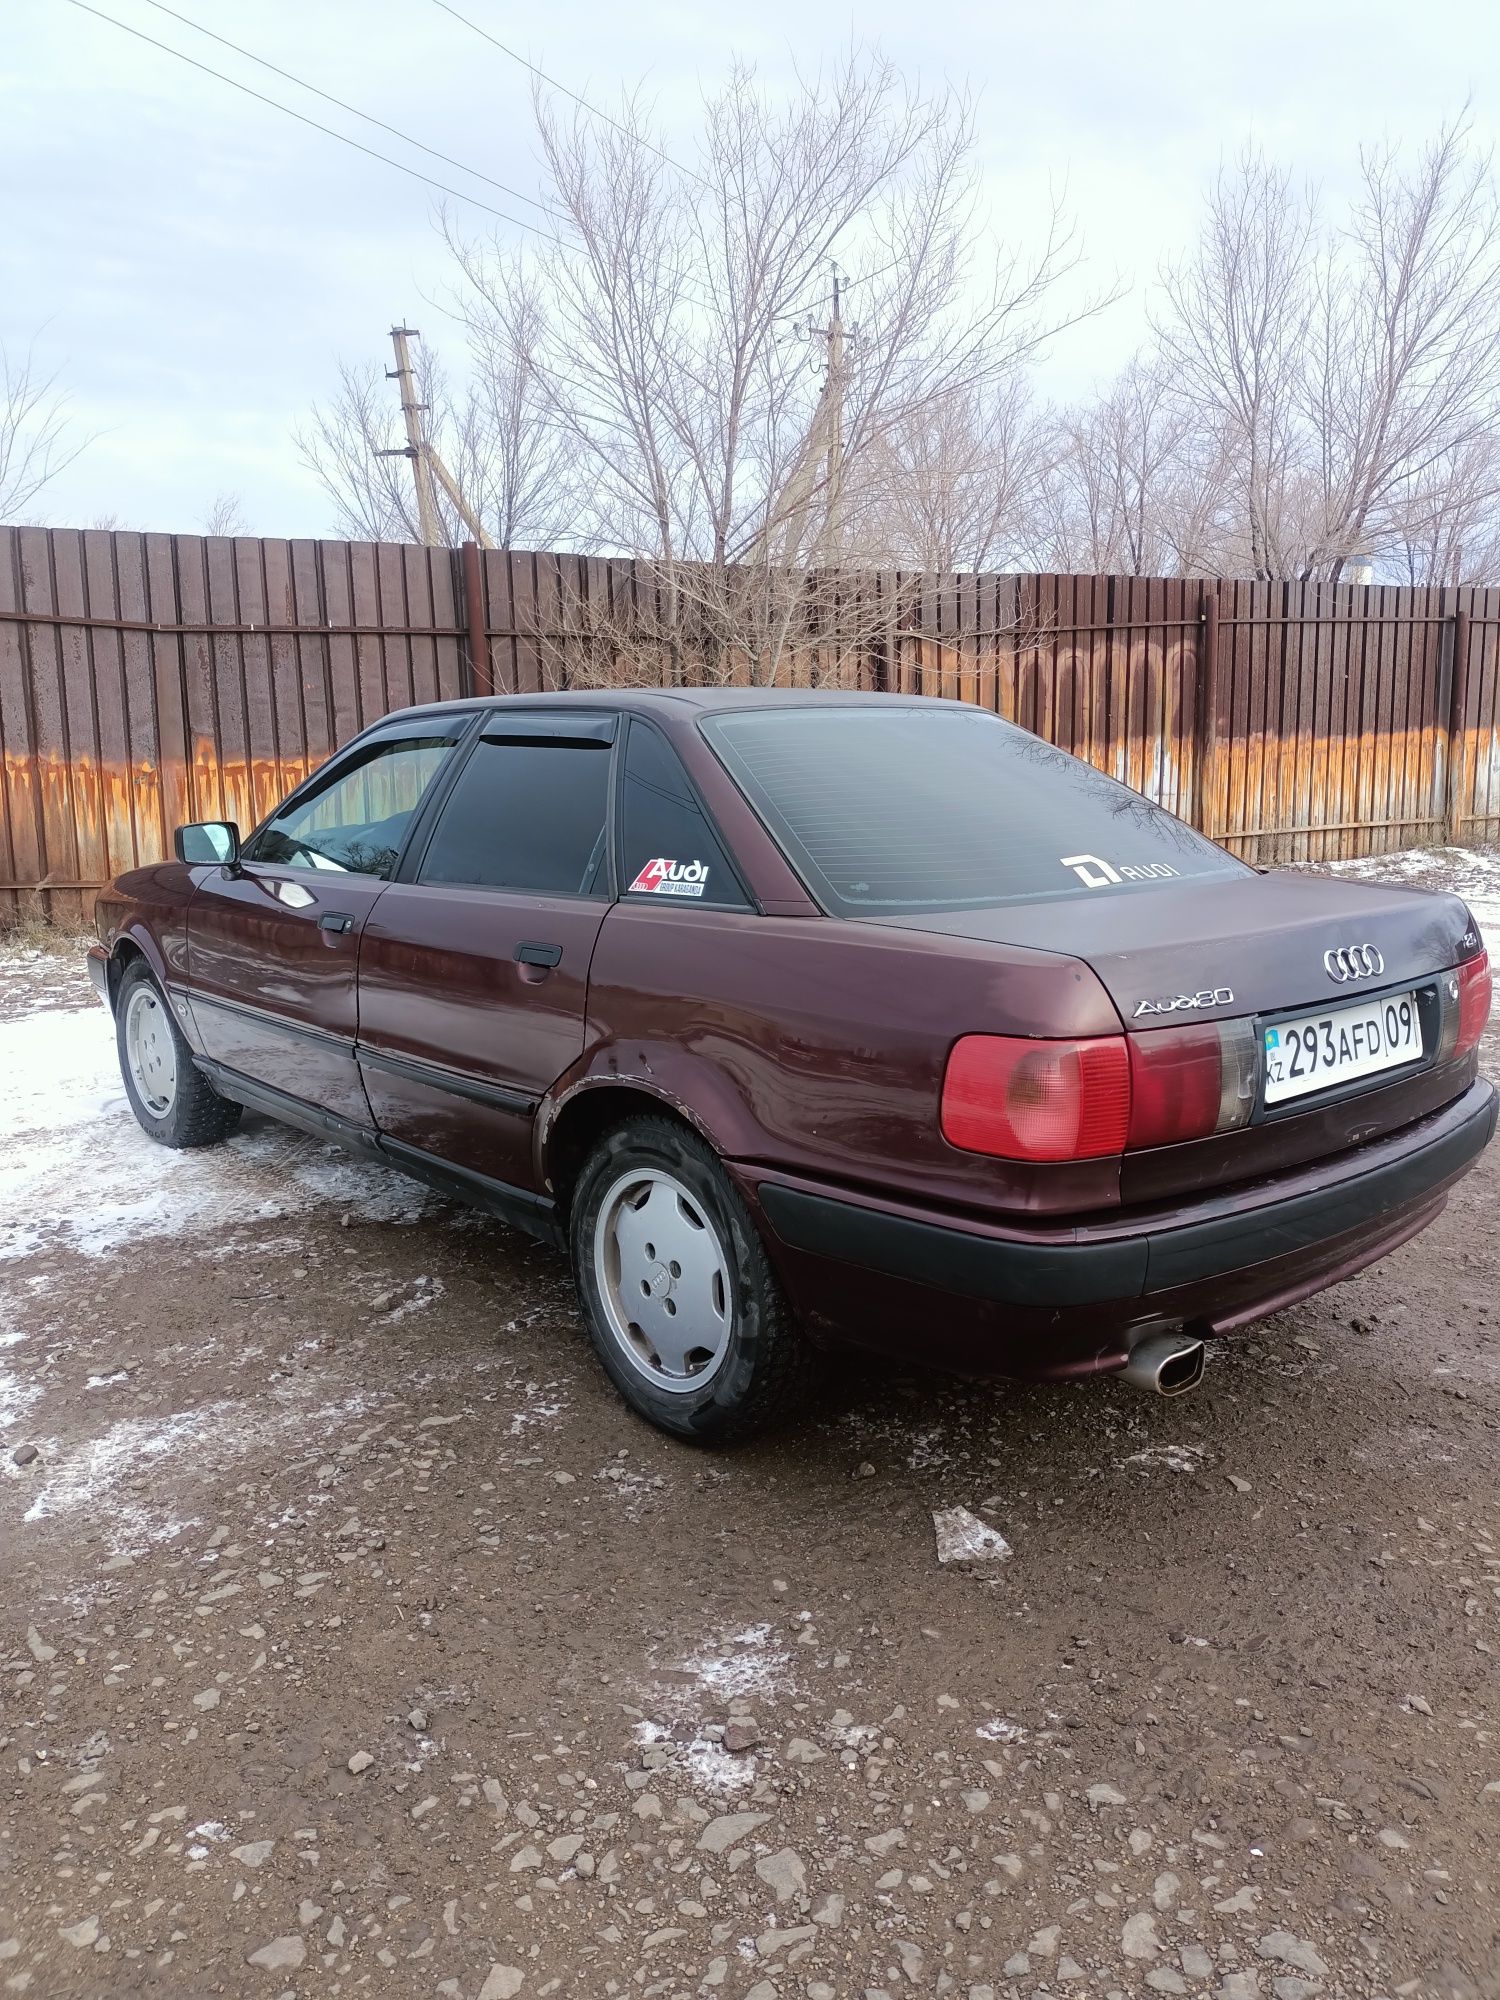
(90, 690, 1496, 1442)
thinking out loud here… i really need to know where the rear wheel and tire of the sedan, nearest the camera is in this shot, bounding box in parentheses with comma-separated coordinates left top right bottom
(568, 1116, 814, 1444)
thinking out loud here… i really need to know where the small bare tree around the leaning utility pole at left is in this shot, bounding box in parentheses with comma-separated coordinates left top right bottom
(296, 320, 576, 548)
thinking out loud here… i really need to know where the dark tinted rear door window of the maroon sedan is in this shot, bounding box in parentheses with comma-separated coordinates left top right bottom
(420, 736, 610, 896)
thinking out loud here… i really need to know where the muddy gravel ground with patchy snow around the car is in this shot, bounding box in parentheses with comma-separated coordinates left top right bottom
(0, 854, 1500, 2000)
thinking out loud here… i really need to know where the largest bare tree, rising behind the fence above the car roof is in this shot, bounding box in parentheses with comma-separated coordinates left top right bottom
(448, 52, 1100, 680)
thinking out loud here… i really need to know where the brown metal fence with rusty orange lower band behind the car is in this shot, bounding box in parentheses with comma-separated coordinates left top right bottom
(0, 528, 1500, 924)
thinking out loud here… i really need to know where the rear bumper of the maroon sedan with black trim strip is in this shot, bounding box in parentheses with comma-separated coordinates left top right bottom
(752, 1082, 1496, 1374)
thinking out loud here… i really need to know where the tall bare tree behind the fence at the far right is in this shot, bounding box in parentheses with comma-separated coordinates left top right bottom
(1156, 120, 1500, 580)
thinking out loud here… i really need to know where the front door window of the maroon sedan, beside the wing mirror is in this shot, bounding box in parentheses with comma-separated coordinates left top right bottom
(246, 716, 468, 882)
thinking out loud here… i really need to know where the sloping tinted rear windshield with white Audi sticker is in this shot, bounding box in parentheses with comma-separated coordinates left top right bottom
(704, 702, 1244, 916)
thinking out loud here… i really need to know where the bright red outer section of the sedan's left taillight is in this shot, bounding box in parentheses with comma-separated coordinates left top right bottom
(942, 1034, 1130, 1160)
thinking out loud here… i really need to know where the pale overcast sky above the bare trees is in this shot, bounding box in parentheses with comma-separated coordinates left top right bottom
(0, 0, 1500, 534)
